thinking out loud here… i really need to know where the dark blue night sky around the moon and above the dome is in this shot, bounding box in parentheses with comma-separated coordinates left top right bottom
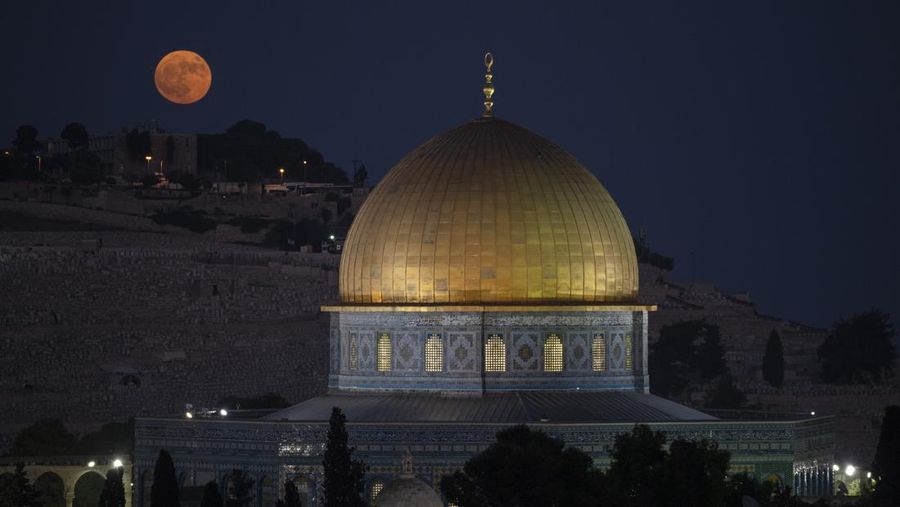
(0, 0, 900, 326)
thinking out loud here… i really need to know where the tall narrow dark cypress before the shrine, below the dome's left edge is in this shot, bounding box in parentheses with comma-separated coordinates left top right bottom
(322, 407, 366, 507)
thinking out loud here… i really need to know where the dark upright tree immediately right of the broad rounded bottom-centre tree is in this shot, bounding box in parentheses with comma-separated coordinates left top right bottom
(607, 424, 666, 505)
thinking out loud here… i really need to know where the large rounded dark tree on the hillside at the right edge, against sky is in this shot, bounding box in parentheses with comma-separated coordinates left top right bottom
(818, 309, 897, 384)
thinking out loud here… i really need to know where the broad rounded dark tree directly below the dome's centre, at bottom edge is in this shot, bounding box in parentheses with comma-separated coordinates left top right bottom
(441, 425, 605, 506)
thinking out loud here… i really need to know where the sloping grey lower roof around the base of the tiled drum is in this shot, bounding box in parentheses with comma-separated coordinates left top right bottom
(264, 391, 716, 425)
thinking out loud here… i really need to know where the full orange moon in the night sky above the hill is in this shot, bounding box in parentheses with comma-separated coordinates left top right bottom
(153, 50, 212, 104)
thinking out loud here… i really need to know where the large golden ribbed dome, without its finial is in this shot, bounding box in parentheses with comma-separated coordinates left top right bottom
(340, 116, 638, 305)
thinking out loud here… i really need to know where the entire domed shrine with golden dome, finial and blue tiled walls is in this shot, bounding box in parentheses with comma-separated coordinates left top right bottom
(134, 56, 834, 505)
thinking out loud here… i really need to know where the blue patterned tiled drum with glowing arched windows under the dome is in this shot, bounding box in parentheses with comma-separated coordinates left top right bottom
(329, 308, 649, 394)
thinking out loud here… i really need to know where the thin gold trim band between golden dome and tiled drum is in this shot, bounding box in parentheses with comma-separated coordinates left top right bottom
(321, 303, 656, 313)
